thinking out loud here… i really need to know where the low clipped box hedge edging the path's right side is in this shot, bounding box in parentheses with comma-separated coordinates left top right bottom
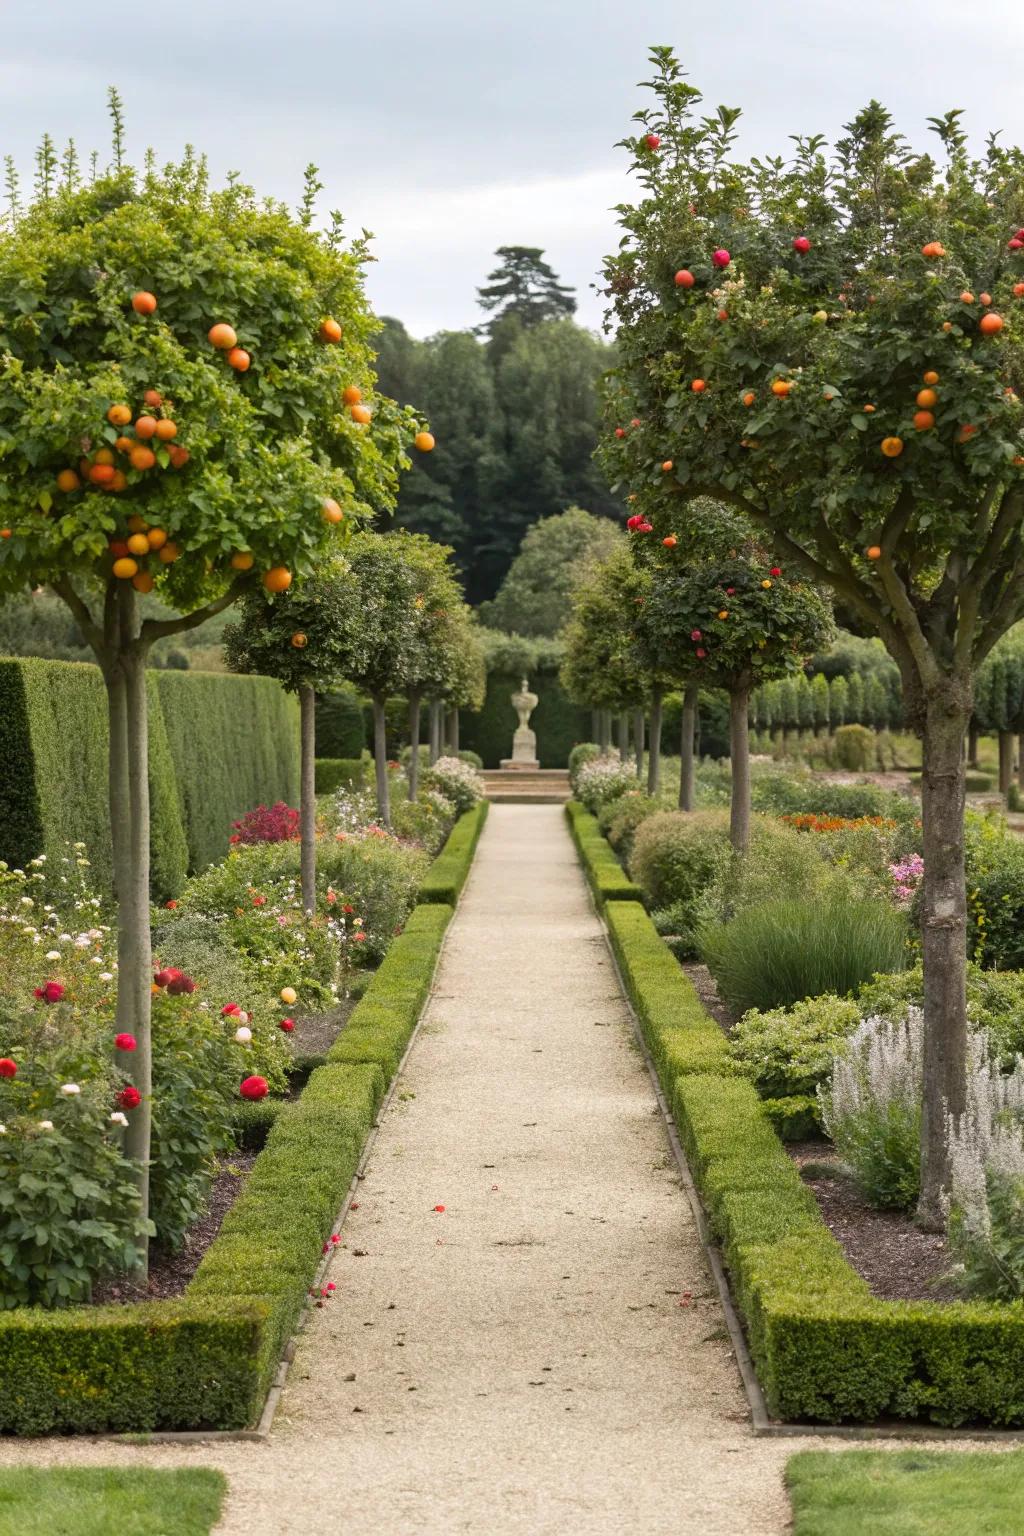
(570, 822, 1024, 1428)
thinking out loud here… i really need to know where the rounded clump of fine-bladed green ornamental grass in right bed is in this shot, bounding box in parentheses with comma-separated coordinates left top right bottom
(700, 897, 907, 1012)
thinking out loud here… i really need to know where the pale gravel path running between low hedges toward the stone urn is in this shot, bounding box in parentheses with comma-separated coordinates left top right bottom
(0, 805, 988, 1536)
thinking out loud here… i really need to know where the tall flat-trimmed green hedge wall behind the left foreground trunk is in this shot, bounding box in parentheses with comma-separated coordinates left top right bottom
(0, 657, 298, 902)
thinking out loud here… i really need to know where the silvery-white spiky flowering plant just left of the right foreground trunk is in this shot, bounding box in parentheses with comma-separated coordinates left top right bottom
(818, 1008, 924, 1210)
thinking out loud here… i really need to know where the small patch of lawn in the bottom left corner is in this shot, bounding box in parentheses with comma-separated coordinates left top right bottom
(0, 1467, 227, 1536)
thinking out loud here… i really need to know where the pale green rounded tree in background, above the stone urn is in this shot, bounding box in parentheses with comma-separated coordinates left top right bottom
(481, 507, 623, 637)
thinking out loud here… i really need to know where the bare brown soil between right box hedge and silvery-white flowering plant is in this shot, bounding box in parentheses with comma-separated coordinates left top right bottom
(786, 1141, 960, 1301)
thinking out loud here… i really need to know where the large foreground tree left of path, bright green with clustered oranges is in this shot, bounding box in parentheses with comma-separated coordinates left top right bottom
(0, 95, 428, 1265)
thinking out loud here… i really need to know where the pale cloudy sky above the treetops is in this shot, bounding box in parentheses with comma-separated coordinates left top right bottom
(0, 0, 1024, 336)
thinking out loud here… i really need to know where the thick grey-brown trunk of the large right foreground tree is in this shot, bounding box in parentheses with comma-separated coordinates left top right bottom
(918, 693, 967, 1232)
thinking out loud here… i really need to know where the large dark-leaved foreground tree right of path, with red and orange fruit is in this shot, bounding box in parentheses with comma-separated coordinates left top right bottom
(602, 49, 1024, 1227)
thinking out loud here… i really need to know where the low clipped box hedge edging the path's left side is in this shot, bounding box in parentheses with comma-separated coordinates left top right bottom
(0, 813, 484, 1435)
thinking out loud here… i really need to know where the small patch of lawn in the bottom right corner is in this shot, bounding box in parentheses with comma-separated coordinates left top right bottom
(786, 1450, 1024, 1536)
